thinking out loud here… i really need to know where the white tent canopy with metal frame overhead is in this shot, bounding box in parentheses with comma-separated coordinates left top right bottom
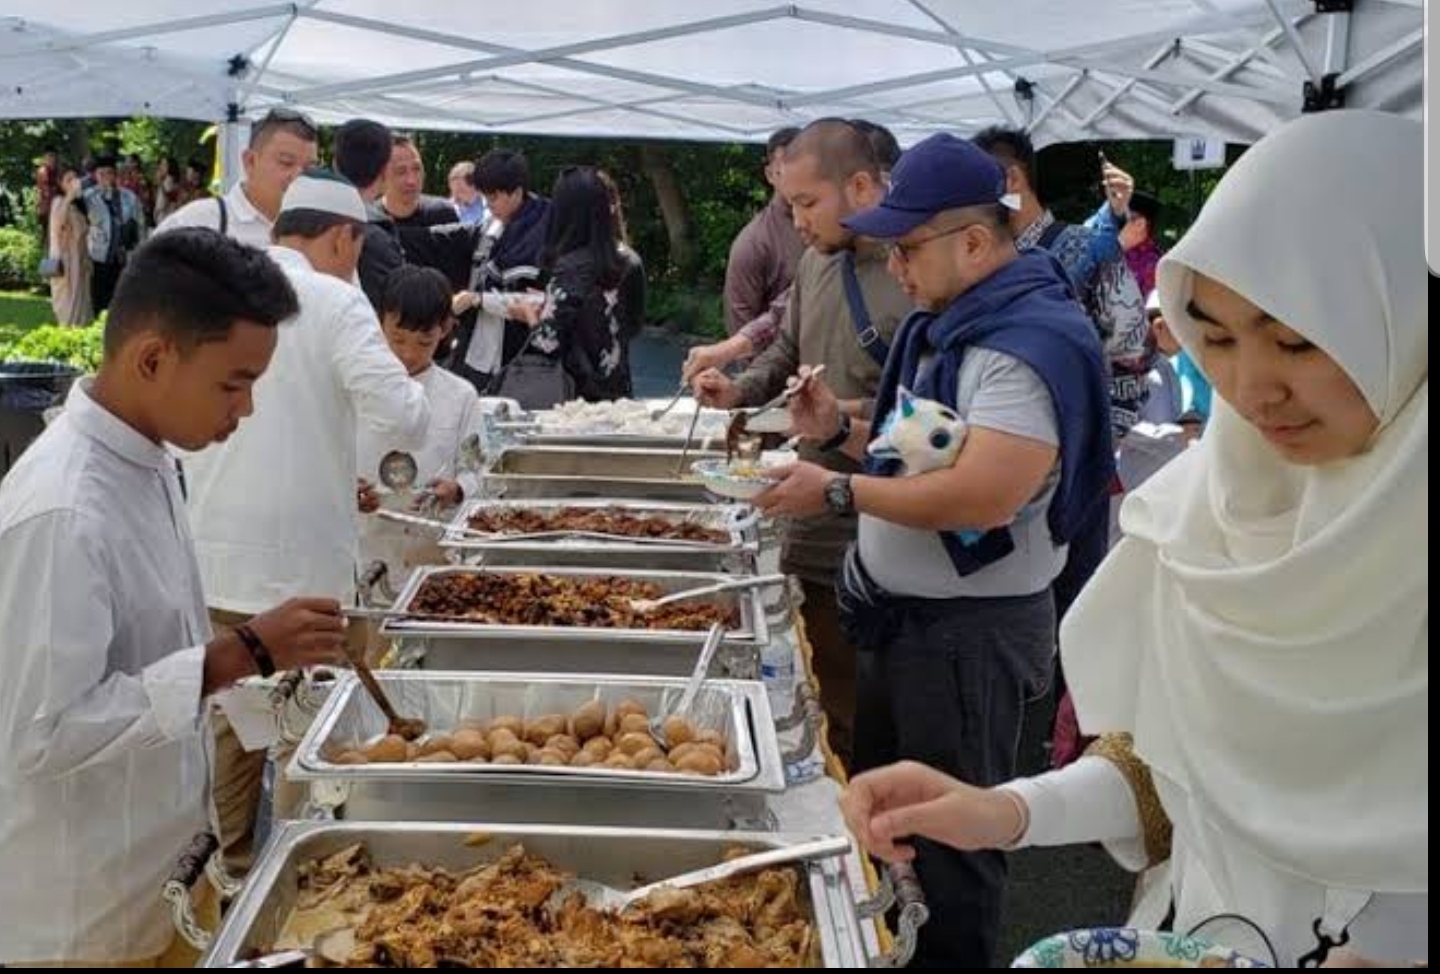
(0, 0, 1424, 144)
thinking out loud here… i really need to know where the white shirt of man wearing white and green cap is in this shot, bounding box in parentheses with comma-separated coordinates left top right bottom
(186, 246, 429, 612)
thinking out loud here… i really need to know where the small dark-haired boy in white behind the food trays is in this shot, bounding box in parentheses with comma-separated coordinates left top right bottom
(359, 265, 481, 572)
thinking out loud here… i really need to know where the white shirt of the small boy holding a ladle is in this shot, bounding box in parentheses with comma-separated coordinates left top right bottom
(357, 365, 482, 581)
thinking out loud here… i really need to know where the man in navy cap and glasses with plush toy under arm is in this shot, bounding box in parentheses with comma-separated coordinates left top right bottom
(757, 135, 1115, 967)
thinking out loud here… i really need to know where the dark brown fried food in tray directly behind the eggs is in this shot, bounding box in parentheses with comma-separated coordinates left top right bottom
(408, 572, 736, 633)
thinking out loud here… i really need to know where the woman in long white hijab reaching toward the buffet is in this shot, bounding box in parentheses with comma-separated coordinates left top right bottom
(845, 112, 1430, 967)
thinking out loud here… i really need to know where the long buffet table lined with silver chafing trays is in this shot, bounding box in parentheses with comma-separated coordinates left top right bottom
(168, 412, 926, 967)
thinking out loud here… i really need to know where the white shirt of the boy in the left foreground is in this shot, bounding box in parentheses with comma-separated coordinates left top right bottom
(0, 383, 210, 964)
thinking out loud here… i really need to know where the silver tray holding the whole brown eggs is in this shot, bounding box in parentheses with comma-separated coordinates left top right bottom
(289, 670, 785, 792)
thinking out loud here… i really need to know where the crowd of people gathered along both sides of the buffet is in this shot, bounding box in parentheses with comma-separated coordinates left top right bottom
(0, 111, 1428, 967)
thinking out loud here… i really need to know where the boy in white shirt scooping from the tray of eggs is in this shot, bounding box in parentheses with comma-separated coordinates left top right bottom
(0, 229, 344, 967)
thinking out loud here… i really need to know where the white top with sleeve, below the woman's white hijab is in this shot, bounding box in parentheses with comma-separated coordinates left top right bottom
(1007, 758, 1430, 967)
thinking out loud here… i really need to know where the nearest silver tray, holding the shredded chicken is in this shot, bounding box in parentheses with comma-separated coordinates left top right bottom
(200, 823, 870, 967)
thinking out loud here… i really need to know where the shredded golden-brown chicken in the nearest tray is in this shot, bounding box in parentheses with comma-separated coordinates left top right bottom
(287, 846, 818, 967)
